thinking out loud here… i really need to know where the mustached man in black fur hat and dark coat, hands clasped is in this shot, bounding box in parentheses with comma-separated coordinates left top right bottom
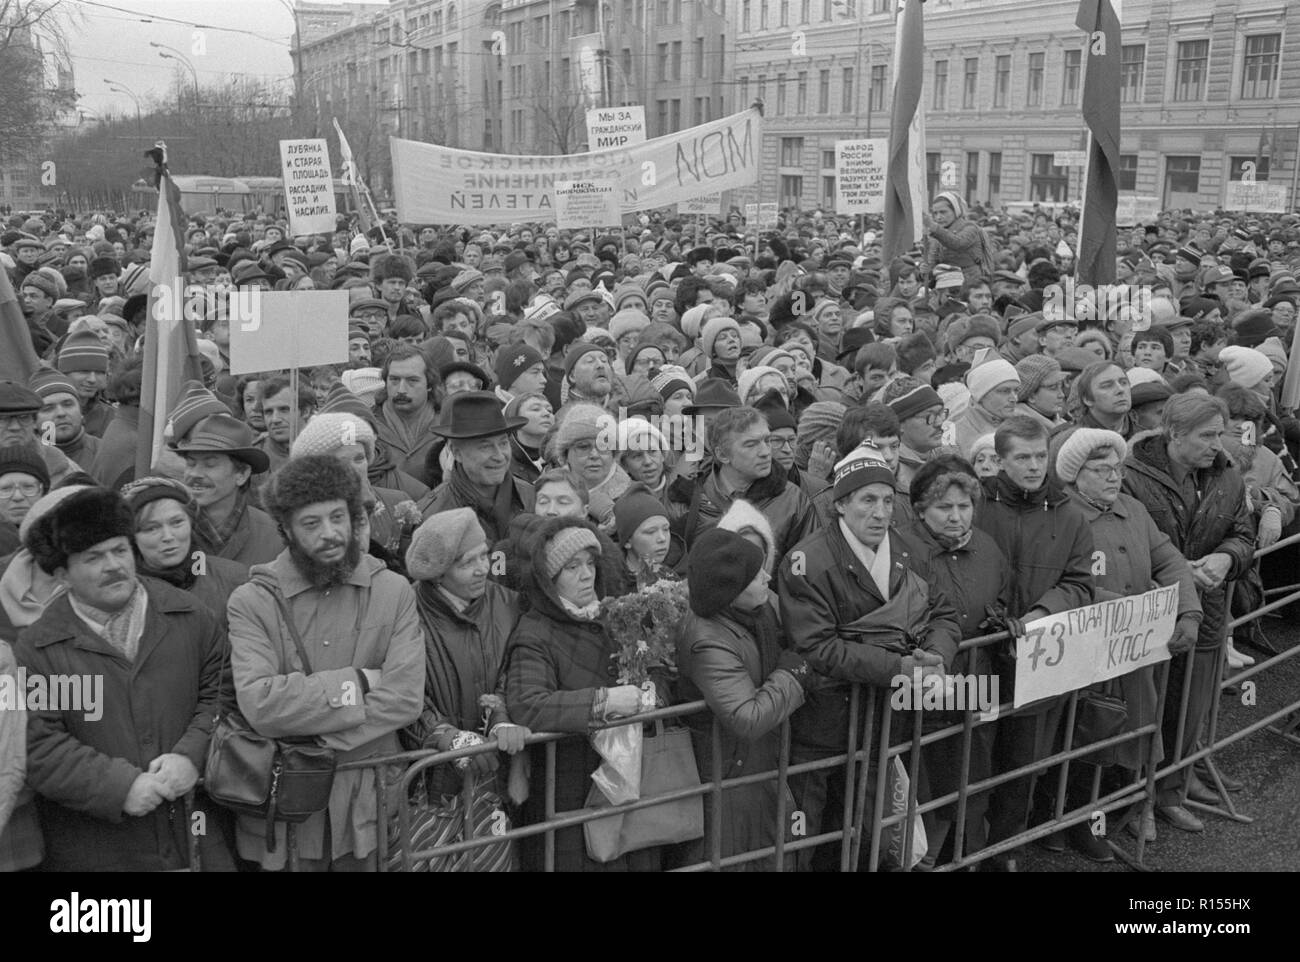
(14, 486, 225, 872)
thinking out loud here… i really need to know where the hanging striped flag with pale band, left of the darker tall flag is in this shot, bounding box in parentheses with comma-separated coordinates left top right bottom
(881, 0, 928, 267)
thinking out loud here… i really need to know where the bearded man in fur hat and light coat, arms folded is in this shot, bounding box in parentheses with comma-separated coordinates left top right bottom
(228, 455, 424, 872)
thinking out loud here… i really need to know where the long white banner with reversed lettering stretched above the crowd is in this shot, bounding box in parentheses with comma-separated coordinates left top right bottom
(390, 108, 762, 224)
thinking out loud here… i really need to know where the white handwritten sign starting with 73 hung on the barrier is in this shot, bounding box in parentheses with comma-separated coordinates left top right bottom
(1014, 585, 1178, 709)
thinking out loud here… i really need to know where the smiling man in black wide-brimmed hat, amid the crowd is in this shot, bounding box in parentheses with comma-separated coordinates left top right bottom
(419, 391, 533, 545)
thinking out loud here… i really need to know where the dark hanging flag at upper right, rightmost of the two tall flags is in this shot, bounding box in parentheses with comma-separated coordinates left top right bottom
(1075, 0, 1121, 285)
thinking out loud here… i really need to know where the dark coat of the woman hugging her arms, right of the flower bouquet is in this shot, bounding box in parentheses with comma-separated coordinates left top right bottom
(677, 611, 803, 871)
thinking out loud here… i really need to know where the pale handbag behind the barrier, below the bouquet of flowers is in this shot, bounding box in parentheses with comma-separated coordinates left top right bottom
(582, 722, 705, 862)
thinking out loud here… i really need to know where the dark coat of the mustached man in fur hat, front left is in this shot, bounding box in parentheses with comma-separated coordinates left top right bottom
(14, 579, 225, 872)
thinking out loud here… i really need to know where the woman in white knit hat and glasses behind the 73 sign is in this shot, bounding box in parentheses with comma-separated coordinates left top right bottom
(1056, 428, 1201, 861)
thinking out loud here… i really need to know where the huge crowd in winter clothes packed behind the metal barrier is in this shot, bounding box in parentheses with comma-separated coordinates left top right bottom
(0, 192, 1300, 871)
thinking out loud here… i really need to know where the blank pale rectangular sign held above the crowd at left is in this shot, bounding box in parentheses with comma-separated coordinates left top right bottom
(230, 291, 348, 374)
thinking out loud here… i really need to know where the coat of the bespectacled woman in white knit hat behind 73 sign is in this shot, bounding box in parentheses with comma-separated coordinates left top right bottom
(1070, 491, 1201, 771)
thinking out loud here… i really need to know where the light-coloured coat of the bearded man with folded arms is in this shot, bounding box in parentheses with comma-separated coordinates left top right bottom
(228, 549, 424, 868)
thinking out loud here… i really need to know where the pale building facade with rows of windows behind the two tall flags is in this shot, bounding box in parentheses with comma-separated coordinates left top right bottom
(731, 0, 1300, 209)
